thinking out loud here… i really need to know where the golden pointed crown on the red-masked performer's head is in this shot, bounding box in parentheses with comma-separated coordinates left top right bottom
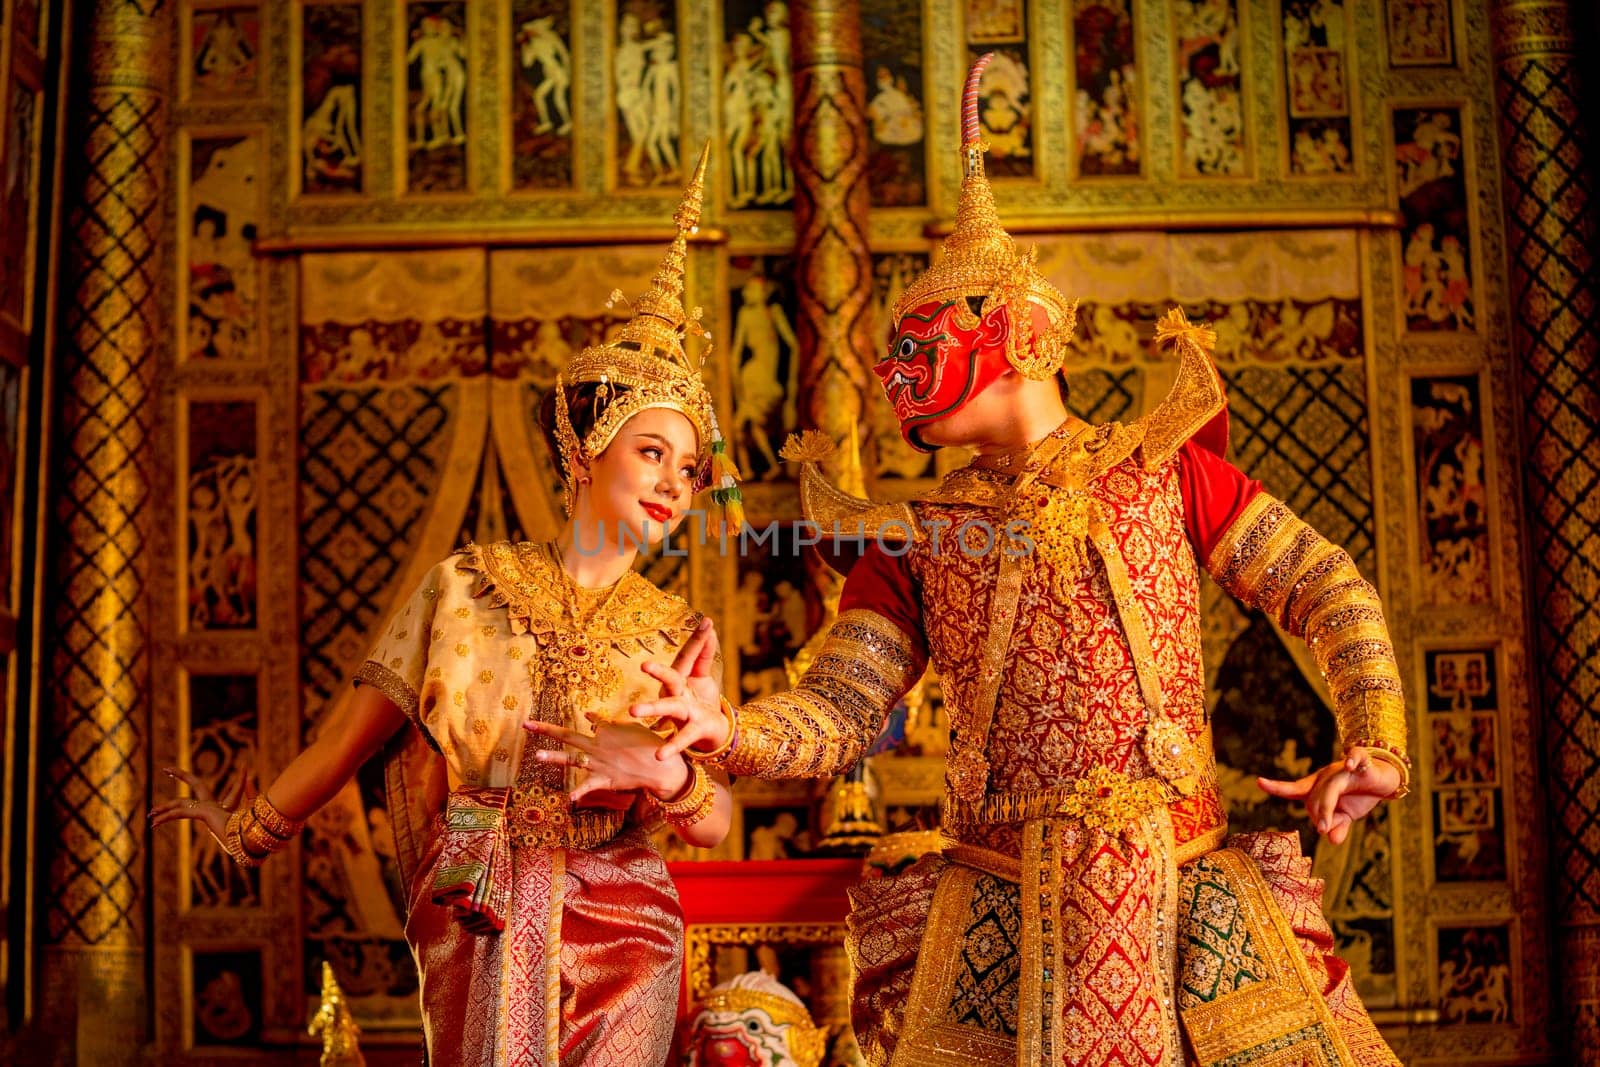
(891, 53, 1078, 381)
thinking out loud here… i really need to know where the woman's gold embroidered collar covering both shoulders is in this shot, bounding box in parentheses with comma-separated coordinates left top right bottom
(456, 541, 701, 648)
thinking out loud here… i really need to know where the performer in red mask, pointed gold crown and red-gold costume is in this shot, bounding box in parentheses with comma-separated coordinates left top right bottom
(635, 61, 1408, 1067)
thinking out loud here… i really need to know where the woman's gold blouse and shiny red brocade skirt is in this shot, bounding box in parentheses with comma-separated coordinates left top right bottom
(357, 542, 699, 1067)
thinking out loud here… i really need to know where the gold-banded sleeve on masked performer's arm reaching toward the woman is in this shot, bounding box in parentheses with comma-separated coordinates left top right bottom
(723, 608, 922, 777)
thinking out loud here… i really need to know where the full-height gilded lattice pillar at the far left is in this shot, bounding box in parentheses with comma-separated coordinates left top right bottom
(40, 0, 176, 1064)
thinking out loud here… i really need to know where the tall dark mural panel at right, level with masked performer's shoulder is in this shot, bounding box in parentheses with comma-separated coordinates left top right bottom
(1411, 374, 1494, 605)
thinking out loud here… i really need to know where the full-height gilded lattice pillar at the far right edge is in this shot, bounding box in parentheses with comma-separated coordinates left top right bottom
(1494, 0, 1600, 1064)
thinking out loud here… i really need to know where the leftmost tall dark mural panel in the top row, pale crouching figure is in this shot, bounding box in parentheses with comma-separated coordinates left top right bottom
(299, 3, 365, 194)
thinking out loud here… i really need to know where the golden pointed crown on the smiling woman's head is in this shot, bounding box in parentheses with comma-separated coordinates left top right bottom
(555, 142, 718, 478)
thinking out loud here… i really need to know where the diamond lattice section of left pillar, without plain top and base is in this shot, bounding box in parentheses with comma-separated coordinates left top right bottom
(45, 90, 166, 945)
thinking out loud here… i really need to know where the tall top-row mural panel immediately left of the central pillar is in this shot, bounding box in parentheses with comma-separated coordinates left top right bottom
(720, 0, 795, 208)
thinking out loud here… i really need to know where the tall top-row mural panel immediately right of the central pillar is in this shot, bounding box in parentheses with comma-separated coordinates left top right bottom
(861, 0, 928, 208)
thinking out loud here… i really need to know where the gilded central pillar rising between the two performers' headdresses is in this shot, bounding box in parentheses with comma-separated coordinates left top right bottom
(790, 0, 877, 493)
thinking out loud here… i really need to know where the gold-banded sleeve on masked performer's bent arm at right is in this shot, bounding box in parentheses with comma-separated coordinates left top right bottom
(1208, 493, 1410, 795)
